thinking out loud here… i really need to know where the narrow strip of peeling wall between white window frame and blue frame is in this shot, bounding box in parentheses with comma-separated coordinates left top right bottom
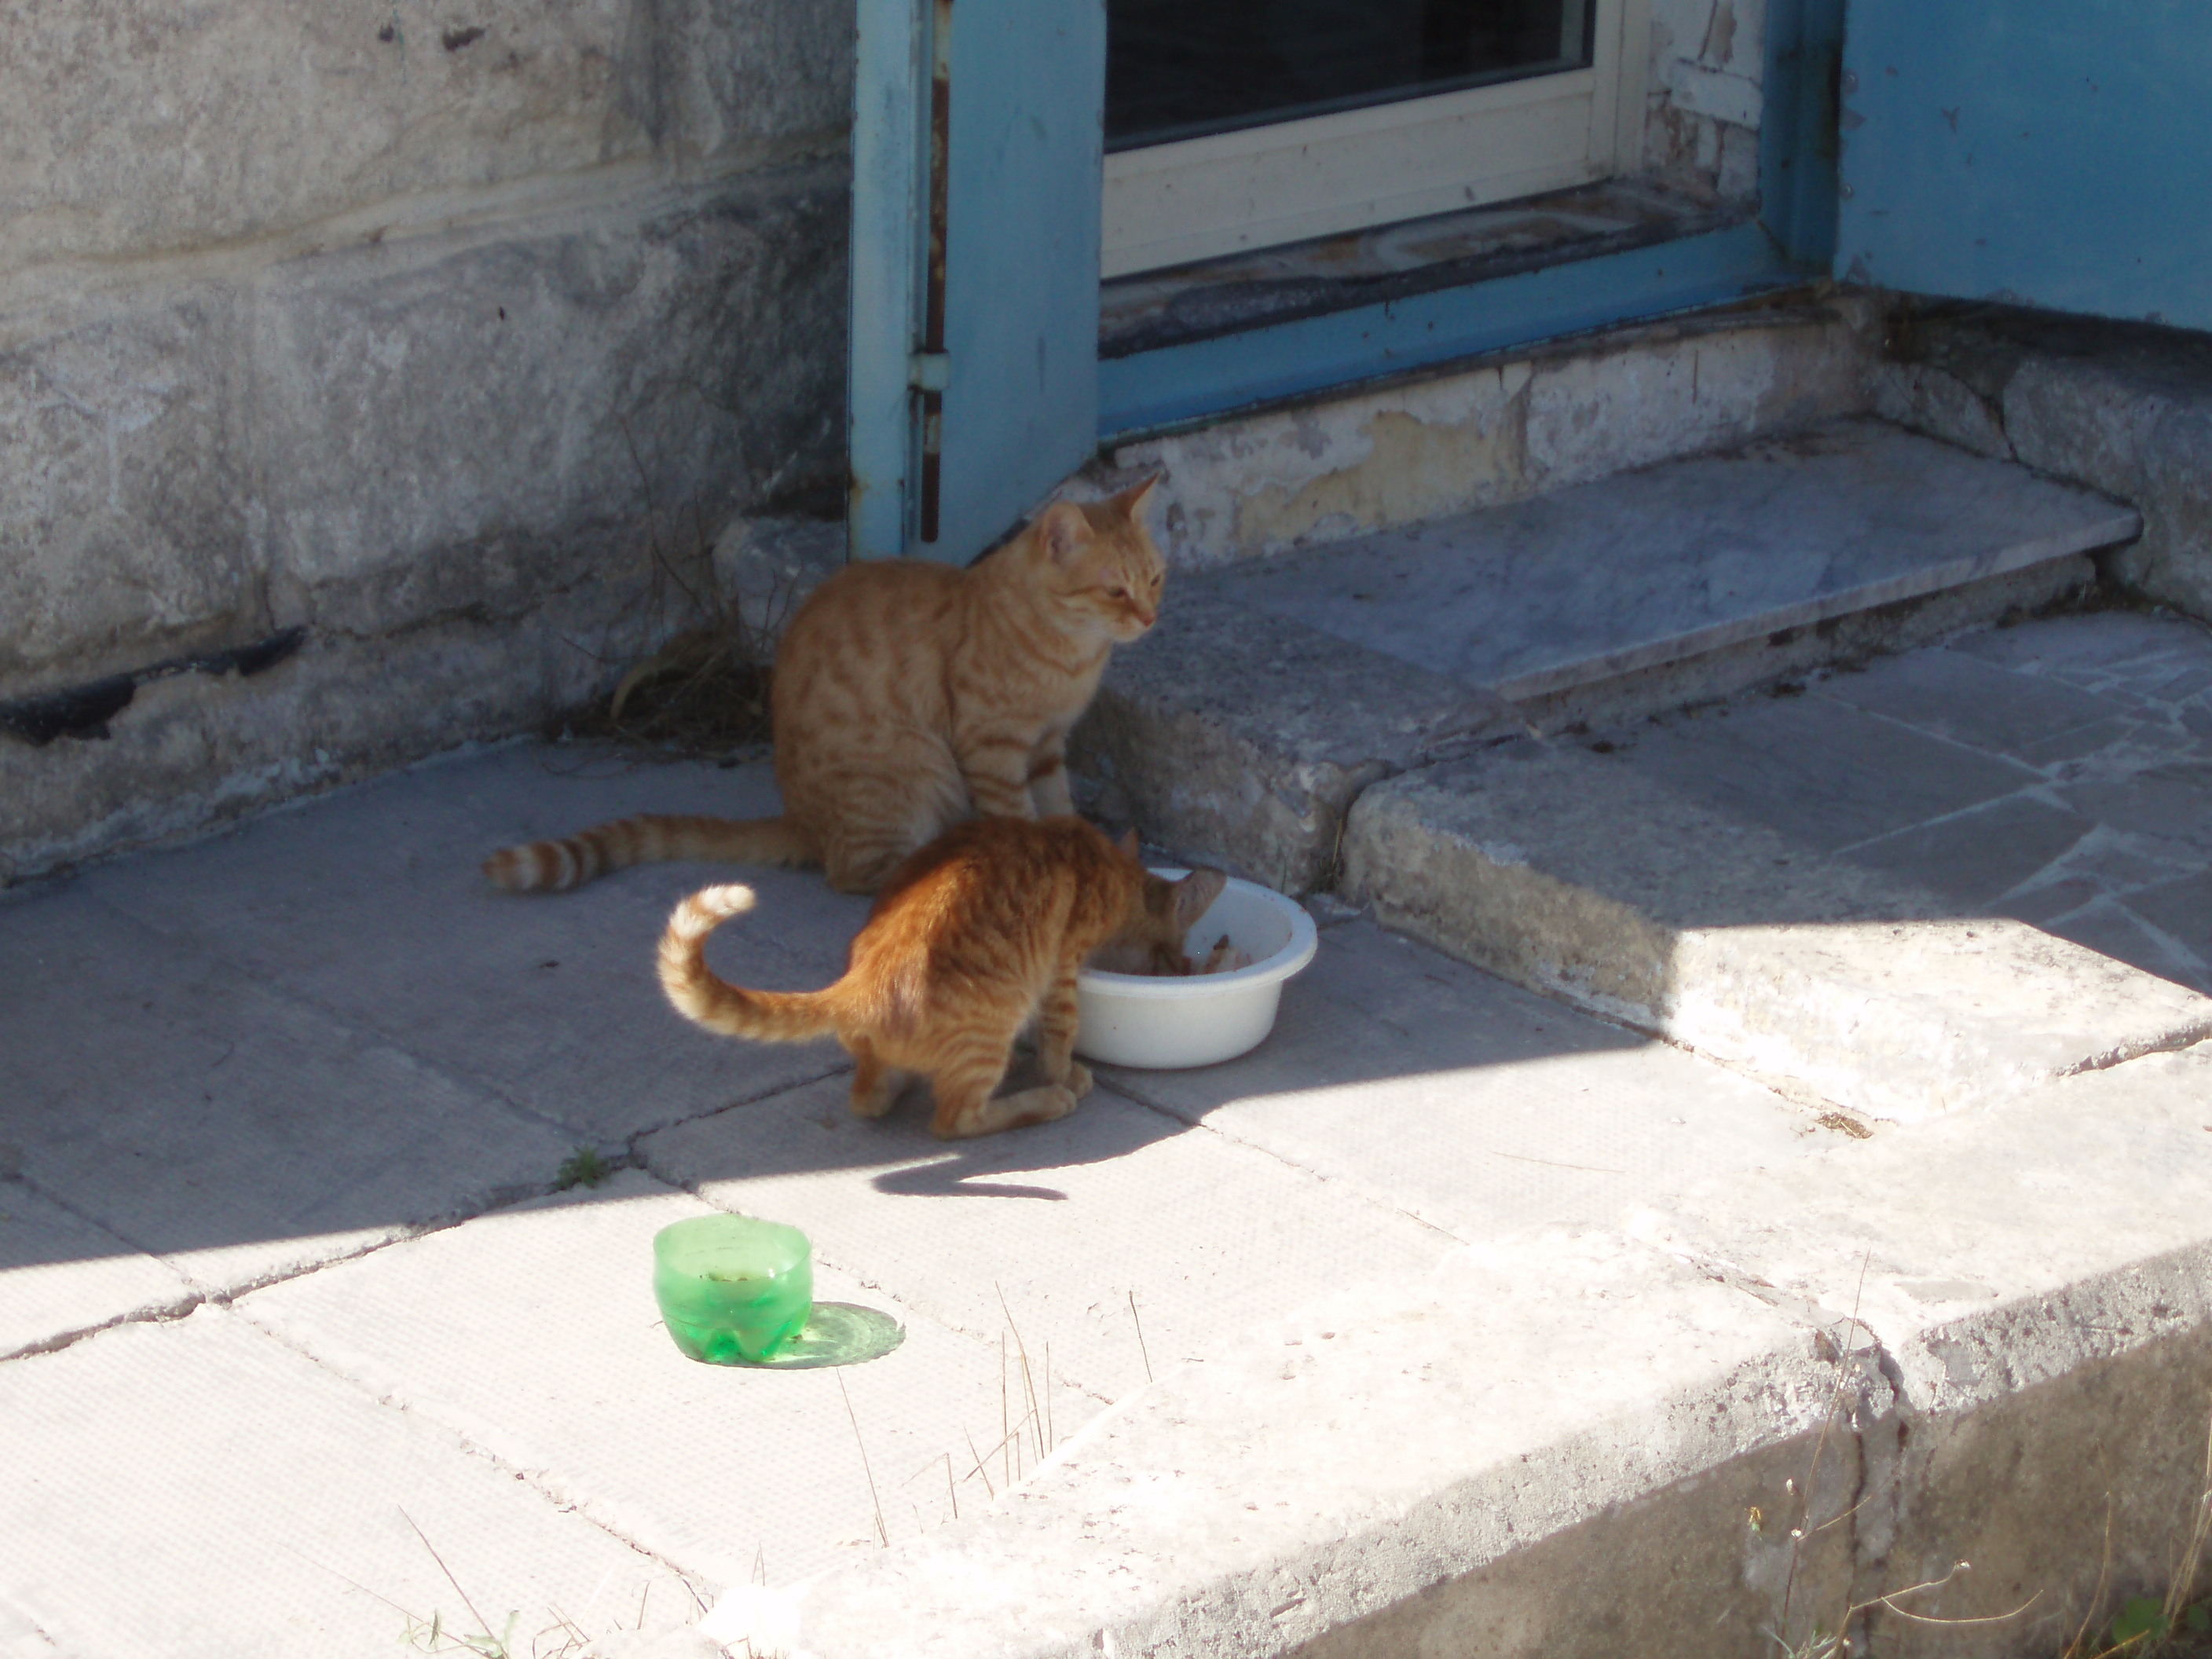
(1643, 0, 1767, 203)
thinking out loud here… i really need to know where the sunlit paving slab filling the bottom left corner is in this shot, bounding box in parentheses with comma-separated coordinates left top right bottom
(0, 1307, 672, 1659)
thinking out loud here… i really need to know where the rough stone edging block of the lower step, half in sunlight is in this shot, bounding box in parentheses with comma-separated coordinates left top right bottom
(1342, 741, 2212, 1122)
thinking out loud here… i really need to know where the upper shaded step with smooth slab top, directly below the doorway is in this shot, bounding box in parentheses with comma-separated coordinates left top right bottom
(1075, 420, 2139, 892)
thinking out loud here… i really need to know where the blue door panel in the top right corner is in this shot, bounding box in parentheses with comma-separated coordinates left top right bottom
(1836, 0, 2212, 328)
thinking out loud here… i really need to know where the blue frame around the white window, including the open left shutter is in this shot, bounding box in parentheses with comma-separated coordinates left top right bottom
(849, 0, 1849, 478)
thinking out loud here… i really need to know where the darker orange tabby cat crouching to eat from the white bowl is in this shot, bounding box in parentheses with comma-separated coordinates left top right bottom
(661, 819, 1228, 1139)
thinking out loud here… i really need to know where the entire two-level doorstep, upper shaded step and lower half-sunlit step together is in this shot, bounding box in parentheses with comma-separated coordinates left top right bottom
(1077, 420, 2212, 1122)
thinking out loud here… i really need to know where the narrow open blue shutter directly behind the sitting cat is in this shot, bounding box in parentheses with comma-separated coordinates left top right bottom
(849, 0, 1106, 564)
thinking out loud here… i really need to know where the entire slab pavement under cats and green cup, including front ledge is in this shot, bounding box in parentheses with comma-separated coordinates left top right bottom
(0, 619, 2212, 1659)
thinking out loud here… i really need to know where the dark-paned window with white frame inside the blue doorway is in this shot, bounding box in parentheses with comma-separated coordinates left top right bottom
(1101, 0, 1646, 279)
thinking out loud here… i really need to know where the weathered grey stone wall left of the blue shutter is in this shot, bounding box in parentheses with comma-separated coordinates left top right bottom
(0, 0, 851, 881)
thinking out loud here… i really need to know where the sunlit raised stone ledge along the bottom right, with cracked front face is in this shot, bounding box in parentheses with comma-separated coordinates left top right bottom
(703, 1049, 2212, 1659)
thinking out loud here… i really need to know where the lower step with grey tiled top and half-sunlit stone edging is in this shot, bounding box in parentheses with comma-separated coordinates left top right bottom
(1342, 613, 2212, 1122)
